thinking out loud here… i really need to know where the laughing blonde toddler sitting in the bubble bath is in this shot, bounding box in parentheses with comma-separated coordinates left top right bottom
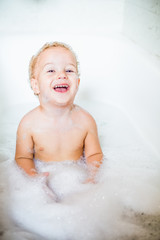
(15, 42, 103, 182)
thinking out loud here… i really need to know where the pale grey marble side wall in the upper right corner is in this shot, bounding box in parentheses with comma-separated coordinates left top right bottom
(123, 0, 160, 57)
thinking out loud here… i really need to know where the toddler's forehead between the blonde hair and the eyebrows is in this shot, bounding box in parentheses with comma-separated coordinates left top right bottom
(37, 47, 76, 65)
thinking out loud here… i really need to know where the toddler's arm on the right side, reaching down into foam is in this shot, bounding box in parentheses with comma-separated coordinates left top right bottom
(85, 118, 103, 182)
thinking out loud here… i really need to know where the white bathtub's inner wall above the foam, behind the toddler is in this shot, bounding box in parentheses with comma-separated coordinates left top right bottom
(0, 35, 160, 156)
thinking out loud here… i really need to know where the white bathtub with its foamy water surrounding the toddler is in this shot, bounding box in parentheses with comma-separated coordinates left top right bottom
(0, 36, 160, 240)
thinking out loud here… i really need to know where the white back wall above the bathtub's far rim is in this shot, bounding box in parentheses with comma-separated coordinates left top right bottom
(0, 0, 124, 35)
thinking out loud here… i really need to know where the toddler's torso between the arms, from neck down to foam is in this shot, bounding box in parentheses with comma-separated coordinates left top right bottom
(32, 104, 87, 162)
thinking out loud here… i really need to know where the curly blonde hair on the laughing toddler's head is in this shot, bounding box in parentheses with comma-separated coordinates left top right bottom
(29, 42, 79, 79)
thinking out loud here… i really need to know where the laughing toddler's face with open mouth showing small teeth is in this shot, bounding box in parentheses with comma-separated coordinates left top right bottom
(31, 47, 80, 105)
